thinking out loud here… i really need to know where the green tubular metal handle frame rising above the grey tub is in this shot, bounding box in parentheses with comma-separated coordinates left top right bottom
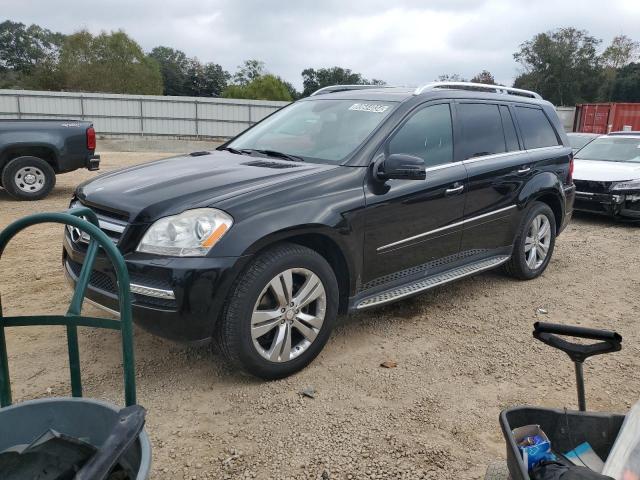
(0, 207, 136, 407)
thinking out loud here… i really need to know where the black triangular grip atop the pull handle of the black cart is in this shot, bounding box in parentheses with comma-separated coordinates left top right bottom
(533, 322, 622, 363)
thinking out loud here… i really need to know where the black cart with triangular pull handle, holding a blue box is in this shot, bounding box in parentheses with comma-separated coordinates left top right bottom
(485, 322, 625, 480)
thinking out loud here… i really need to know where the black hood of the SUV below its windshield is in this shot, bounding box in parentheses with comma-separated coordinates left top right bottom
(76, 151, 338, 223)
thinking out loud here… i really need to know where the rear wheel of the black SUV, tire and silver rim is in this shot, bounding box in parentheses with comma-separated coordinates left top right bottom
(504, 202, 556, 280)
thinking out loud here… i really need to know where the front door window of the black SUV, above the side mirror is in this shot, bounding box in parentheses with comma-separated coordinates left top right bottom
(387, 103, 453, 167)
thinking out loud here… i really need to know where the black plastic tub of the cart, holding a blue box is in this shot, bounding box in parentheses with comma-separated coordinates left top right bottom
(500, 407, 624, 480)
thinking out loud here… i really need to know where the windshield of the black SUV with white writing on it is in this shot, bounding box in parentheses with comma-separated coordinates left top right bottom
(229, 99, 395, 163)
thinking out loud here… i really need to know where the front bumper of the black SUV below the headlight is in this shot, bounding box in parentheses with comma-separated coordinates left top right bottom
(62, 229, 249, 343)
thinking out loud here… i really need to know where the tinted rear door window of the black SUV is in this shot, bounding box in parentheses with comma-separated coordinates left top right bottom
(457, 103, 506, 160)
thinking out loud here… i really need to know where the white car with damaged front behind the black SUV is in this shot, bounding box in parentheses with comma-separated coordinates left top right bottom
(573, 132, 640, 221)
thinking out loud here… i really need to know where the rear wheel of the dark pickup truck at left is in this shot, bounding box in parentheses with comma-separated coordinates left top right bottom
(2, 156, 56, 200)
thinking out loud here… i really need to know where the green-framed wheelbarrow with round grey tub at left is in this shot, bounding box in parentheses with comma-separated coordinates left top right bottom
(0, 208, 151, 480)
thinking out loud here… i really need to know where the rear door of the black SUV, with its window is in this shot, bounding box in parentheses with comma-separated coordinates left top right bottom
(455, 100, 533, 256)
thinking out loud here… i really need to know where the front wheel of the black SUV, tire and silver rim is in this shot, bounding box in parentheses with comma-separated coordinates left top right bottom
(217, 243, 339, 380)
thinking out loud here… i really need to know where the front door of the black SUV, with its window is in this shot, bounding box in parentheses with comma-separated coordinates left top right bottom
(362, 102, 466, 289)
